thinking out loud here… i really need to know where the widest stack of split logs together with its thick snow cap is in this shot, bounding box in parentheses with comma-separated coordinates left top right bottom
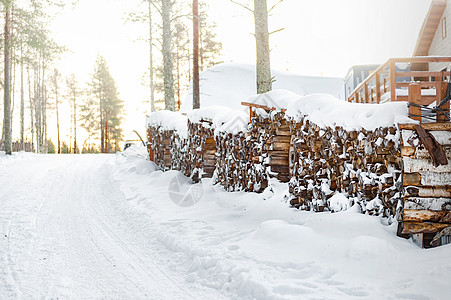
(285, 94, 414, 217)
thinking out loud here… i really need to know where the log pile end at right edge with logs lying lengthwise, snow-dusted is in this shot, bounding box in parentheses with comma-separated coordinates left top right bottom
(398, 123, 451, 247)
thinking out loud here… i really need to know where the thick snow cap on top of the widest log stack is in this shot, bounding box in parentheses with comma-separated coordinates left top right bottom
(285, 94, 416, 130)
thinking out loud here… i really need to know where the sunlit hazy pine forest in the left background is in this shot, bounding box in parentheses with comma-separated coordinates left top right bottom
(0, 0, 222, 154)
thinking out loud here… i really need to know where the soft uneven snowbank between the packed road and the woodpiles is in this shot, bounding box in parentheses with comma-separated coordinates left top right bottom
(114, 156, 451, 299)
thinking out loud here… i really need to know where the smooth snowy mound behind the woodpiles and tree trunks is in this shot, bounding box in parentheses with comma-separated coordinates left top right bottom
(180, 63, 344, 112)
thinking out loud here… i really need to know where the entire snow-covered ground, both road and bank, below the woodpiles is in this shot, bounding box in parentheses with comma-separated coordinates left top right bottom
(0, 147, 451, 299)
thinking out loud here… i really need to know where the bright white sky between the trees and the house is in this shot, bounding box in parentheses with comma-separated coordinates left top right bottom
(47, 0, 430, 144)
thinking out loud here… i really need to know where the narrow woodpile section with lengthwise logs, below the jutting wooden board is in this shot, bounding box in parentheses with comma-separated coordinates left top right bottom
(250, 108, 291, 182)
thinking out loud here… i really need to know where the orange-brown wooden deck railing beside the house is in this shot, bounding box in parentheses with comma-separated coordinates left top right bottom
(348, 56, 451, 119)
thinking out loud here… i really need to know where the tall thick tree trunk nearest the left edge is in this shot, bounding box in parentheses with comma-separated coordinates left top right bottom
(3, 1, 12, 155)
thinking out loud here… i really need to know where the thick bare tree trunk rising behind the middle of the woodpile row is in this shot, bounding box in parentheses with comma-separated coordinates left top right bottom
(254, 0, 272, 94)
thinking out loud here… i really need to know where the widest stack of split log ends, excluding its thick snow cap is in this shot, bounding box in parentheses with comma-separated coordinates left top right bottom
(289, 118, 402, 216)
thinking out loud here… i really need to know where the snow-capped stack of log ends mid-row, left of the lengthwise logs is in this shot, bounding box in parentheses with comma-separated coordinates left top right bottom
(215, 112, 268, 192)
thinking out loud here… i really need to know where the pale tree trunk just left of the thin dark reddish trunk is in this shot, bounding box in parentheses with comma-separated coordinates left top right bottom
(161, 0, 175, 111)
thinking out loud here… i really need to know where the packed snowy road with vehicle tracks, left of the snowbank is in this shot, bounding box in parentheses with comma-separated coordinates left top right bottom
(0, 155, 221, 299)
